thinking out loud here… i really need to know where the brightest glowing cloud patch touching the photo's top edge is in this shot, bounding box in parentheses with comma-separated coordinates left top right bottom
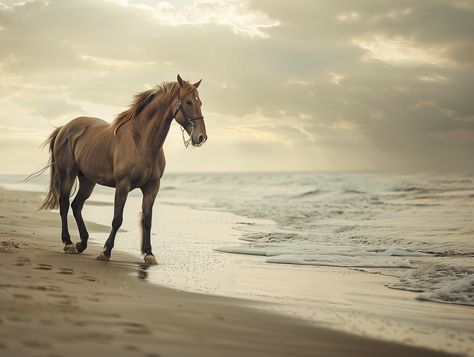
(111, 0, 280, 38)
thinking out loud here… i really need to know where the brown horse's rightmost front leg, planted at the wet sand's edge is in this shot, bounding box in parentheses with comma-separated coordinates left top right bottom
(141, 180, 160, 265)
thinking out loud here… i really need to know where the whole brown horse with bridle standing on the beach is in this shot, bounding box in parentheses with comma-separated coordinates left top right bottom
(41, 75, 207, 264)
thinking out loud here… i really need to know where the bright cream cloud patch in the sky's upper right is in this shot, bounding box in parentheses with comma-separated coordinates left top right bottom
(352, 35, 454, 67)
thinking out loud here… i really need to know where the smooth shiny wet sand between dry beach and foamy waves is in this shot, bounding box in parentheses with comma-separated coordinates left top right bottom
(78, 185, 474, 356)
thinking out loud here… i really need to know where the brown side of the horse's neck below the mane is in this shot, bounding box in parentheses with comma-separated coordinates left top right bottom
(133, 97, 174, 154)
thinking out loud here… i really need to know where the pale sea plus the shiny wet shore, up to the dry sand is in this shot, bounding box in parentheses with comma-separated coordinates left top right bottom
(0, 173, 474, 356)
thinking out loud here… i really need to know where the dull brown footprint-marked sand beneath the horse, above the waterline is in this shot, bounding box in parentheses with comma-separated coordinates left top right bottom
(0, 190, 454, 357)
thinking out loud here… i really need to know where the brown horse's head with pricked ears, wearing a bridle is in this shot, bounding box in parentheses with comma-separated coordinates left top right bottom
(174, 74, 207, 146)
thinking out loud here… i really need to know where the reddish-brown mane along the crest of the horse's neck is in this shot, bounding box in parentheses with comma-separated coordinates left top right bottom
(112, 82, 195, 134)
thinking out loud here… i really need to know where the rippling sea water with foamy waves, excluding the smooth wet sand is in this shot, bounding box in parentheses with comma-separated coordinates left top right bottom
(0, 173, 474, 306)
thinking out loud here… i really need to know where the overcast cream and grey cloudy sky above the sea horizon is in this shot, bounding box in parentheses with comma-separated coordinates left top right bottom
(0, 0, 474, 174)
